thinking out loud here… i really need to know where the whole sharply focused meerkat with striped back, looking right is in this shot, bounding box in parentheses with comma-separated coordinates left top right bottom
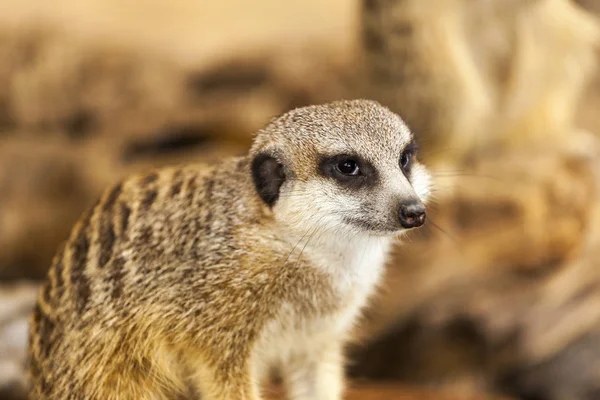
(28, 100, 430, 400)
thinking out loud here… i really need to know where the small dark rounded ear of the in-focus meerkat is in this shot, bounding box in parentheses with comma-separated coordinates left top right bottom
(252, 153, 285, 207)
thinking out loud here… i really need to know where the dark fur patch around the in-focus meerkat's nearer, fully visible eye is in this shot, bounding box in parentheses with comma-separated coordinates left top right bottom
(319, 154, 378, 189)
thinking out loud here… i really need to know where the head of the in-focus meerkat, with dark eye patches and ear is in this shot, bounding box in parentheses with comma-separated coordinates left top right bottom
(250, 100, 430, 236)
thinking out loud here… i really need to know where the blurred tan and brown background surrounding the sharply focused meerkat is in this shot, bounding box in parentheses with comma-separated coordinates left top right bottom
(0, 0, 600, 400)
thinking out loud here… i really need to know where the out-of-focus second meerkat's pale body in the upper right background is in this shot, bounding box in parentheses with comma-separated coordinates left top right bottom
(361, 0, 600, 166)
